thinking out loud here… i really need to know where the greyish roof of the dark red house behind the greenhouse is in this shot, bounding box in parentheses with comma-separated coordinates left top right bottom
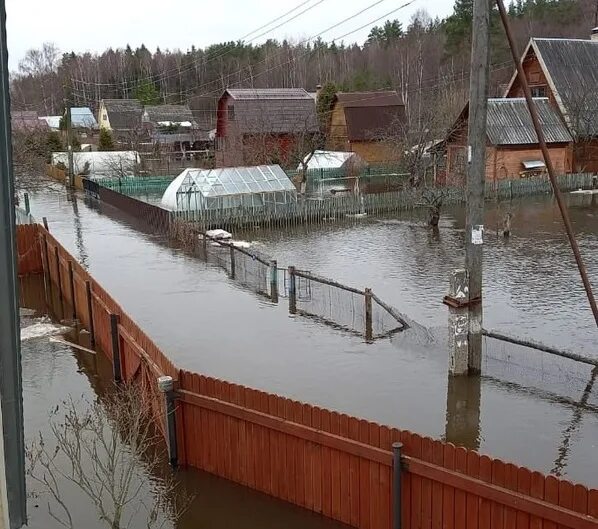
(222, 88, 318, 134)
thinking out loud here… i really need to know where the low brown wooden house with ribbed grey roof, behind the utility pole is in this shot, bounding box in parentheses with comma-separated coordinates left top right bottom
(444, 98, 573, 185)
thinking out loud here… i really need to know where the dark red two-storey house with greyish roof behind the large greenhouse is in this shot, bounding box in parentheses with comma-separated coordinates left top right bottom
(216, 88, 318, 167)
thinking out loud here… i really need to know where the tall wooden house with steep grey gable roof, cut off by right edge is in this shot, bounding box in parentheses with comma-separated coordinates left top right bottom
(505, 34, 598, 172)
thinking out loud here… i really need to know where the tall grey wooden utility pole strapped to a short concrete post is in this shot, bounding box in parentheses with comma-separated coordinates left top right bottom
(465, 0, 490, 374)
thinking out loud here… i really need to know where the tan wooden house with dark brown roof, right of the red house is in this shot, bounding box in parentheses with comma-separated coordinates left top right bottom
(327, 91, 406, 163)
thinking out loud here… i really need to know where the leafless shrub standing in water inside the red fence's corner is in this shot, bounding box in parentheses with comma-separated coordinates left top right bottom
(27, 384, 190, 529)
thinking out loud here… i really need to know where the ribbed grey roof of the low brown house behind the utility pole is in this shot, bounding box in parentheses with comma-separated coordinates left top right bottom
(487, 98, 572, 145)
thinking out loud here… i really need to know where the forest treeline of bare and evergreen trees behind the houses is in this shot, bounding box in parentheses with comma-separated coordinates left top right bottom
(11, 0, 598, 136)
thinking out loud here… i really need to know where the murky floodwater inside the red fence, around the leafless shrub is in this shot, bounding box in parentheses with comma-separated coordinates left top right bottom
(20, 277, 346, 529)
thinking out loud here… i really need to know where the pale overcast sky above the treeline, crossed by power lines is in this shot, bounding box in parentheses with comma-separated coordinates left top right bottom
(6, 0, 453, 70)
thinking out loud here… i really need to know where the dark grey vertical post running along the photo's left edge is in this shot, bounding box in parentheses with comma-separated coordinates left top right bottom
(0, 0, 27, 529)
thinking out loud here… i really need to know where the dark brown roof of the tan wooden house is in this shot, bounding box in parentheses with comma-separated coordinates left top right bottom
(336, 91, 406, 141)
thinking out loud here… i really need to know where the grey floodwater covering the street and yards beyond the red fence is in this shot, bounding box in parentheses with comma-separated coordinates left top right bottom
(25, 185, 598, 486)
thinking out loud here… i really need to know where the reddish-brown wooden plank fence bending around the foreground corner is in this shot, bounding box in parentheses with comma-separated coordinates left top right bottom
(18, 226, 598, 529)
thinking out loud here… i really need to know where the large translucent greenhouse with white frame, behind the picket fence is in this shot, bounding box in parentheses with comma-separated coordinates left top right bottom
(162, 165, 297, 211)
